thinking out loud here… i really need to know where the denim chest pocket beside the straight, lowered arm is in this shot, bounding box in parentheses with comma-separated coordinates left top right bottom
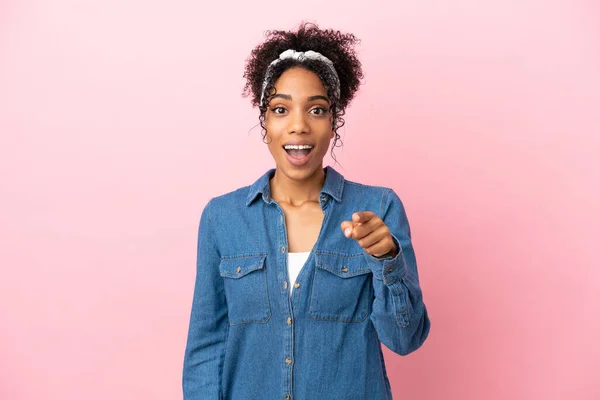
(219, 253, 271, 325)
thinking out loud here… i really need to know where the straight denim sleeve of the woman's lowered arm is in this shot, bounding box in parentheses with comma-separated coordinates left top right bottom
(182, 200, 229, 400)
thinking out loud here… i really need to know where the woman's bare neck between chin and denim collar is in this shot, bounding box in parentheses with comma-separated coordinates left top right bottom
(269, 166, 325, 206)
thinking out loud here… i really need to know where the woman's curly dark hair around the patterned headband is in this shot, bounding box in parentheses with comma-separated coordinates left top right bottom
(243, 23, 363, 162)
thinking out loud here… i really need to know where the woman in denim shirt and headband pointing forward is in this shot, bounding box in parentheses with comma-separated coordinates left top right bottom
(183, 24, 429, 400)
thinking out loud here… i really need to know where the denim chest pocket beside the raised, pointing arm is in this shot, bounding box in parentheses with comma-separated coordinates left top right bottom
(310, 251, 372, 322)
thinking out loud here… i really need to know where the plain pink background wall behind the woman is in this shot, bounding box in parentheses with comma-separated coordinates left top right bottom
(0, 0, 600, 400)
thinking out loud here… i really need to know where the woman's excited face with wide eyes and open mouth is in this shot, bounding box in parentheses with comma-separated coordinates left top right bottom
(265, 67, 334, 180)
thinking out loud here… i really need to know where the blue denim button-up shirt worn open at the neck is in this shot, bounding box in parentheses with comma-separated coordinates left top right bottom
(183, 166, 429, 400)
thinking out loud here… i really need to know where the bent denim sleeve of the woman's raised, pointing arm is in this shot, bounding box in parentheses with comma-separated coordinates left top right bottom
(365, 188, 430, 355)
